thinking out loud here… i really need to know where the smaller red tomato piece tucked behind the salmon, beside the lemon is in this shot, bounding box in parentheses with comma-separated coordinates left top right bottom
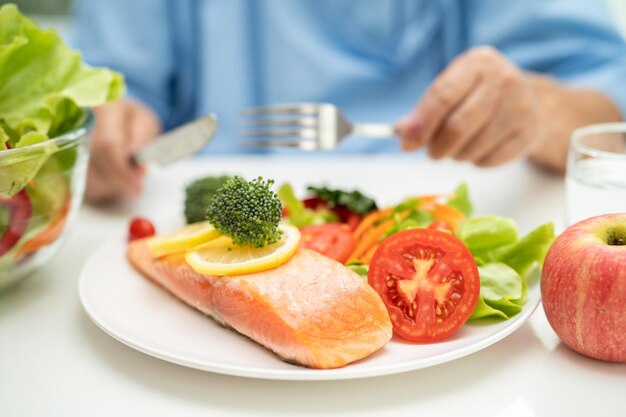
(300, 223, 356, 263)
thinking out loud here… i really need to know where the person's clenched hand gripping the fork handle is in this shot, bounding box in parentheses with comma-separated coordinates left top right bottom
(397, 47, 543, 166)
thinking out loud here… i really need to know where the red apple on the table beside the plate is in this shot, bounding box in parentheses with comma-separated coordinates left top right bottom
(541, 213, 626, 362)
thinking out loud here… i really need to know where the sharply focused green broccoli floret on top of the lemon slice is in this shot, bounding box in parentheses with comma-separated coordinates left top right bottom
(207, 177, 282, 248)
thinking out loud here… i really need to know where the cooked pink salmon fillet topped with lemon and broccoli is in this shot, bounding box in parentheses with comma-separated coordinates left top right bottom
(127, 240, 392, 369)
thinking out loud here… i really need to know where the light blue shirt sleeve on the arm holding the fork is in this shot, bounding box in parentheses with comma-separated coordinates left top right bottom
(464, 0, 626, 116)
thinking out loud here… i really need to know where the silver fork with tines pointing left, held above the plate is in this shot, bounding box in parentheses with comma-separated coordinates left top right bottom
(242, 103, 396, 151)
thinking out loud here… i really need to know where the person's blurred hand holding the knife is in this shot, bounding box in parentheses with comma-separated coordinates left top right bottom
(85, 100, 161, 203)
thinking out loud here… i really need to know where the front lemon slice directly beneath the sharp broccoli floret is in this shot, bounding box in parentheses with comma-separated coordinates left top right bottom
(185, 224, 300, 275)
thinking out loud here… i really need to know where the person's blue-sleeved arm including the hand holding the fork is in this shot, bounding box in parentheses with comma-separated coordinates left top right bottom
(398, 0, 626, 171)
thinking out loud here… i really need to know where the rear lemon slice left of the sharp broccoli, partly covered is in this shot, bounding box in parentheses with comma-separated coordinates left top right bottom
(146, 222, 220, 258)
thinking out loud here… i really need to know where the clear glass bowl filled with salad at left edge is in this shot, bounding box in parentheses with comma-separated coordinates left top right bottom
(0, 111, 93, 289)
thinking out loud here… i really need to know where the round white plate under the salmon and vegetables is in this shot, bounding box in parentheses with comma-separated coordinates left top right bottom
(79, 238, 540, 381)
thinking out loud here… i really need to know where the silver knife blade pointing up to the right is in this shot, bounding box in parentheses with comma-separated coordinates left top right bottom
(132, 114, 217, 165)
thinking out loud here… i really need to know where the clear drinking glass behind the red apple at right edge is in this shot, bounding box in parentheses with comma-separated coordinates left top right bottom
(565, 123, 626, 226)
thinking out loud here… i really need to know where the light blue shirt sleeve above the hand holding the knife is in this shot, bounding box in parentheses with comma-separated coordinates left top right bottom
(72, 0, 173, 125)
